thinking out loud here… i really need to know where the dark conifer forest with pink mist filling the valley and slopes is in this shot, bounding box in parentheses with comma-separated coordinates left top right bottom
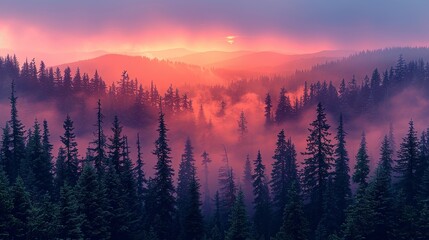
(0, 52, 429, 240)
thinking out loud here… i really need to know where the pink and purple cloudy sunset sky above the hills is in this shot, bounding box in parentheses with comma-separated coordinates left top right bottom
(0, 0, 429, 58)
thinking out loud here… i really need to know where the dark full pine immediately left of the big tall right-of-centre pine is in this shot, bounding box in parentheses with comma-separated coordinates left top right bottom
(271, 130, 298, 231)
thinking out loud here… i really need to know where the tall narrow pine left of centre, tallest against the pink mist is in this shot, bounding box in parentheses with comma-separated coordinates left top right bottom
(152, 112, 175, 239)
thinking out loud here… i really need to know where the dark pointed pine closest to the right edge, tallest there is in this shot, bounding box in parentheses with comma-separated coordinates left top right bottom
(394, 120, 420, 204)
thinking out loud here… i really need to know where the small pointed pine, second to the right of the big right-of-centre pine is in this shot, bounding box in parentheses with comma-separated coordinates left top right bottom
(353, 133, 369, 189)
